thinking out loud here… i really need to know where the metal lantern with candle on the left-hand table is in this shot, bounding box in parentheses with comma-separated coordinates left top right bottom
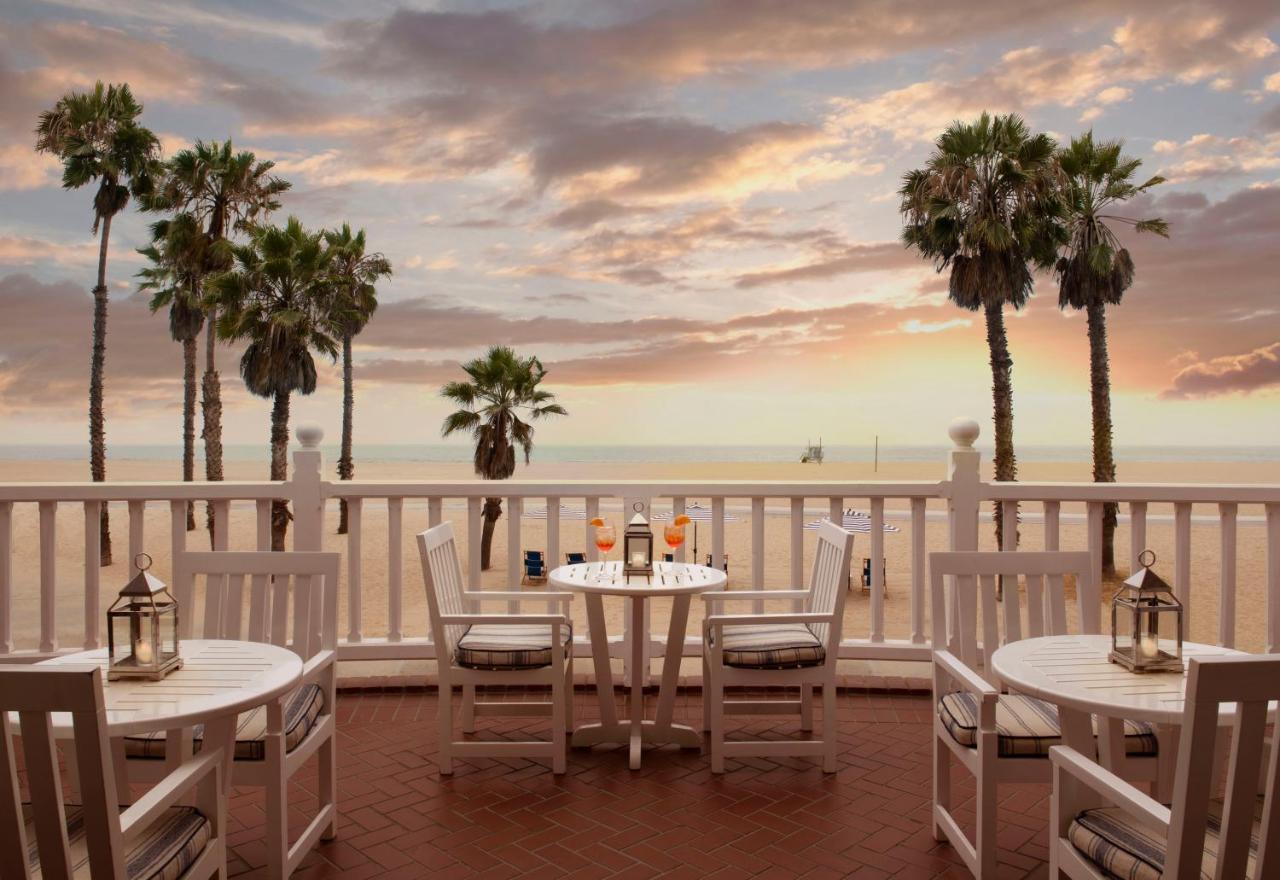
(106, 553, 182, 682)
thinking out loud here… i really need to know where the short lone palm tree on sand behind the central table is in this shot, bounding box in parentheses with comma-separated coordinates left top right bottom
(440, 345, 568, 569)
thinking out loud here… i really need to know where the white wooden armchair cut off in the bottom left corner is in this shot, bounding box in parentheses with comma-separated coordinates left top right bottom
(0, 664, 227, 880)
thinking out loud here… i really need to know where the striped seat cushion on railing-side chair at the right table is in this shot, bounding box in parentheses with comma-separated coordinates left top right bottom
(938, 692, 1157, 757)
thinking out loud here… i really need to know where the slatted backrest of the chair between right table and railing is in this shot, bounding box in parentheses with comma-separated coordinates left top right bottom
(929, 551, 1101, 678)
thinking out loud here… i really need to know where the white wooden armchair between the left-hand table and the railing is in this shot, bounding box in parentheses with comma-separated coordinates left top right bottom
(125, 551, 340, 877)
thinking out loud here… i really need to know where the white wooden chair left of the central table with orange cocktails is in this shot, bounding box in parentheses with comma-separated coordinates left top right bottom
(417, 523, 573, 775)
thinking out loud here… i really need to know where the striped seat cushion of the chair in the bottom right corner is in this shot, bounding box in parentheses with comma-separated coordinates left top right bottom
(1066, 798, 1262, 880)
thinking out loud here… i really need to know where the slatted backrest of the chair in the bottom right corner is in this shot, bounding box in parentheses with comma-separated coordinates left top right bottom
(1161, 654, 1280, 880)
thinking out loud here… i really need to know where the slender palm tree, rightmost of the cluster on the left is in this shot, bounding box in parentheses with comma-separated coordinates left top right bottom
(324, 223, 392, 535)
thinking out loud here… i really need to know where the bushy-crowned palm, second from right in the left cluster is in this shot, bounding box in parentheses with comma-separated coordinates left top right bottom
(209, 217, 338, 550)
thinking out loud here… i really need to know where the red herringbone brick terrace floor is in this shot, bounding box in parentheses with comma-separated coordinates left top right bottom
(229, 691, 1048, 880)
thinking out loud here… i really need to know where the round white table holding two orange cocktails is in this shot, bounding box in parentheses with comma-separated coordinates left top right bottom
(548, 562, 728, 770)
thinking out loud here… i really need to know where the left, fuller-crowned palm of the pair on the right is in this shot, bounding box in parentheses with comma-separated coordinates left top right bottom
(899, 113, 1062, 544)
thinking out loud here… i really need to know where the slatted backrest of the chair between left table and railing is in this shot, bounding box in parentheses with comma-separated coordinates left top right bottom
(174, 550, 342, 660)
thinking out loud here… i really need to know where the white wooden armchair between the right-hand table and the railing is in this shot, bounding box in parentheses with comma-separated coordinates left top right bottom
(929, 551, 1157, 877)
